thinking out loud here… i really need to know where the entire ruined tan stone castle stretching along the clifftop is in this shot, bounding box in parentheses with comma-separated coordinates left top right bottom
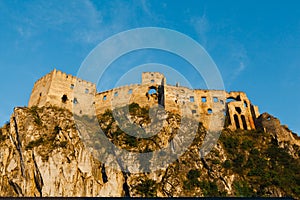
(28, 70, 259, 130)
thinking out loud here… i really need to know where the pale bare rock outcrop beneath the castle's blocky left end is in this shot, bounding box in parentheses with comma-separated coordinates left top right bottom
(0, 108, 124, 196)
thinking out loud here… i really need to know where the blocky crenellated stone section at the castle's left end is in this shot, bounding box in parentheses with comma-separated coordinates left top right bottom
(29, 70, 96, 114)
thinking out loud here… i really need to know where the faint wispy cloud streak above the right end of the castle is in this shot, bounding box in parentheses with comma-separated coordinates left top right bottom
(190, 10, 249, 87)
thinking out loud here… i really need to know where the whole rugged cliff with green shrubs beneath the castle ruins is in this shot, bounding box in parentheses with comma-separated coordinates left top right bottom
(0, 105, 300, 198)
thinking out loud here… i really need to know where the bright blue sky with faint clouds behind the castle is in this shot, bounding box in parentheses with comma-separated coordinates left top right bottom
(0, 0, 300, 133)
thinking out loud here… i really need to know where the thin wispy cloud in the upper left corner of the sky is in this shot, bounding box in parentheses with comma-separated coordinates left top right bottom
(10, 0, 103, 43)
